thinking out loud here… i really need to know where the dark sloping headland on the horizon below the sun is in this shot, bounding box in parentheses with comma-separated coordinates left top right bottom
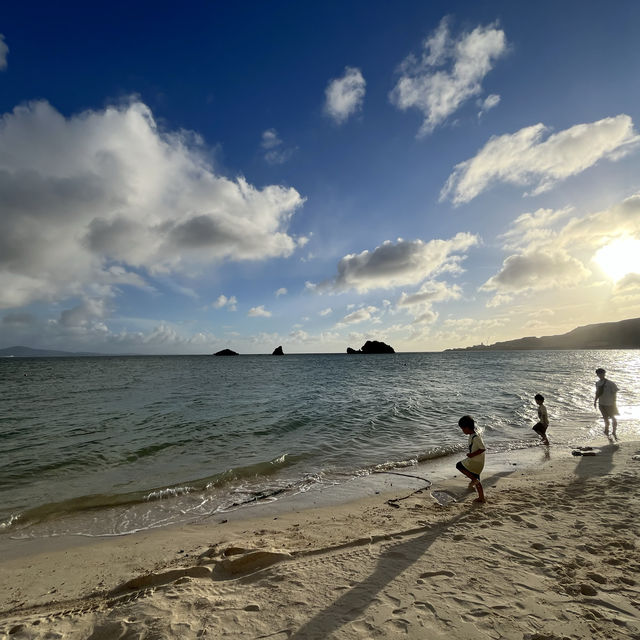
(447, 318, 640, 351)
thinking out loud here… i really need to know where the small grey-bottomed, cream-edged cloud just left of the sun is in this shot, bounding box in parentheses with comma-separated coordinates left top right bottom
(480, 249, 590, 294)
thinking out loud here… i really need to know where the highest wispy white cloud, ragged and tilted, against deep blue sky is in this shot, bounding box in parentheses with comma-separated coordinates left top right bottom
(389, 18, 507, 136)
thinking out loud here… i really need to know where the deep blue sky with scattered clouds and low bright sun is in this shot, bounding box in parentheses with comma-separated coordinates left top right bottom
(0, 0, 640, 354)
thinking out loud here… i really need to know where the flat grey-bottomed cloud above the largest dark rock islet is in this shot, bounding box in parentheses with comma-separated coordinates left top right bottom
(316, 233, 479, 293)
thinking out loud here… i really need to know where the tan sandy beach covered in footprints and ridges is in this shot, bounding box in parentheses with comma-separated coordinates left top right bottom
(0, 442, 640, 640)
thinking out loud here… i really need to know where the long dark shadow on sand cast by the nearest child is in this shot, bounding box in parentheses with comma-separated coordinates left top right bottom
(289, 471, 514, 640)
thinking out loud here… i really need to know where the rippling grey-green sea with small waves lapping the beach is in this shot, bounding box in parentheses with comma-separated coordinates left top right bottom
(0, 350, 640, 538)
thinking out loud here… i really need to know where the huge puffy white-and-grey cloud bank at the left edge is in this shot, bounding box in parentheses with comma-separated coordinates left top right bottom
(0, 101, 303, 308)
